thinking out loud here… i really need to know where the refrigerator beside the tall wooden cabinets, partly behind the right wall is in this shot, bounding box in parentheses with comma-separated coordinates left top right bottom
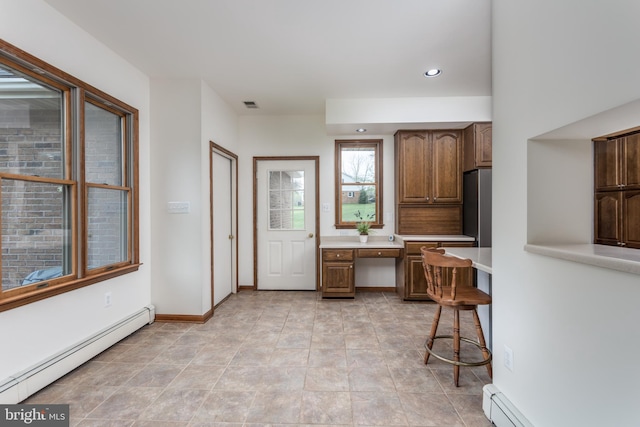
(462, 169, 491, 248)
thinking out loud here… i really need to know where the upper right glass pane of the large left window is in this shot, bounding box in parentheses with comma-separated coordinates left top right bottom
(84, 102, 122, 185)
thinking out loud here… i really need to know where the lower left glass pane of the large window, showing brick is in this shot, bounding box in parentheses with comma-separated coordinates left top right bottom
(1, 179, 71, 291)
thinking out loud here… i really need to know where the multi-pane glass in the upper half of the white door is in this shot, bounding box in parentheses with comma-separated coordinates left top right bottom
(269, 171, 304, 230)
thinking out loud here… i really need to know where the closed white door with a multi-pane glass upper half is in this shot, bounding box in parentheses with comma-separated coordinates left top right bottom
(255, 159, 317, 290)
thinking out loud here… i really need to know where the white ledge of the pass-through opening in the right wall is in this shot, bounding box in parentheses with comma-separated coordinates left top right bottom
(524, 244, 640, 275)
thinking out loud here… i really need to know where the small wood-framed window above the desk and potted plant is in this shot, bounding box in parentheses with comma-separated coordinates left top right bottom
(335, 139, 383, 228)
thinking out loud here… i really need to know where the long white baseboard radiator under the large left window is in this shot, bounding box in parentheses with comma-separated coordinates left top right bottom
(0, 305, 155, 404)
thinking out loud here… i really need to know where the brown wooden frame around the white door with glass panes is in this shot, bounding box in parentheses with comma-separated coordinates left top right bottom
(253, 156, 320, 292)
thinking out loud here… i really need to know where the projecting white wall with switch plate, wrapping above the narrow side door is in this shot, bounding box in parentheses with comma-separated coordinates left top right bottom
(151, 79, 237, 316)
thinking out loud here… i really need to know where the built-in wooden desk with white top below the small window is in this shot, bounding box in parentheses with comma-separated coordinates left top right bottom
(320, 236, 404, 298)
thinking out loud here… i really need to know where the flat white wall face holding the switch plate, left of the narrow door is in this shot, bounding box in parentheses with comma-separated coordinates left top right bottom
(151, 79, 202, 315)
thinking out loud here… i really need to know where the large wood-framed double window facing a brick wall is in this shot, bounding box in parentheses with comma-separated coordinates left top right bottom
(0, 41, 138, 311)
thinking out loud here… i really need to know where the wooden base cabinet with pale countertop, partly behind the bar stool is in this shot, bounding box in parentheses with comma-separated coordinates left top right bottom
(396, 241, 474, 301)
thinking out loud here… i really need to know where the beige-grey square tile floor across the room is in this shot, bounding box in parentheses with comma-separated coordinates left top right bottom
(25, 291, 491, 427)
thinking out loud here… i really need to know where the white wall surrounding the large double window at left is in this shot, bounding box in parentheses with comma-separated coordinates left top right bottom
(0, 0, 152, 380)
